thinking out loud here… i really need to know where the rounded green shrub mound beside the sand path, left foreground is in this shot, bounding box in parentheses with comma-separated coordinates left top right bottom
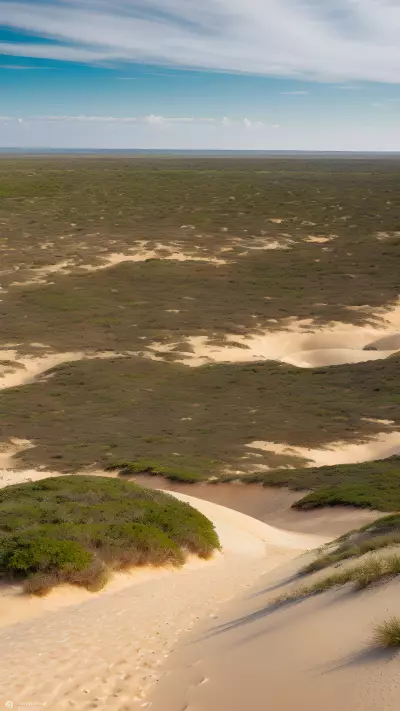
(0, 476, 219, 594)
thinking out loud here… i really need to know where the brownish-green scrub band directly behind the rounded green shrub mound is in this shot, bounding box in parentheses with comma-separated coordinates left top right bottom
(0, 357, 400, 478)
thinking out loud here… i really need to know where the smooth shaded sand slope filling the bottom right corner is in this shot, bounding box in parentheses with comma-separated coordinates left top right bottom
(145, 562, 400, 711)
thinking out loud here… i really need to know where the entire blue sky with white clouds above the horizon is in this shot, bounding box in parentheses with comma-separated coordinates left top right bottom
(0, 0, 400, 151)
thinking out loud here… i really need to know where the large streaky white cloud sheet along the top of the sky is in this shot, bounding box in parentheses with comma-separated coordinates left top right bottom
(0, 0, 400, 83)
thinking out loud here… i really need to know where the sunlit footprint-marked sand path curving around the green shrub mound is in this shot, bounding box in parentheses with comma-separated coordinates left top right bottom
(0, 497, 326, 711)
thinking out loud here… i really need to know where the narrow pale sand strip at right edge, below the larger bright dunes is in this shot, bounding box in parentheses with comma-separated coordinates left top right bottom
(247, 431, 400, 467)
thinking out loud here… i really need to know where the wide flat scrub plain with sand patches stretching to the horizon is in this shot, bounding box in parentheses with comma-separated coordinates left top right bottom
(0, 156, 400, 506)
